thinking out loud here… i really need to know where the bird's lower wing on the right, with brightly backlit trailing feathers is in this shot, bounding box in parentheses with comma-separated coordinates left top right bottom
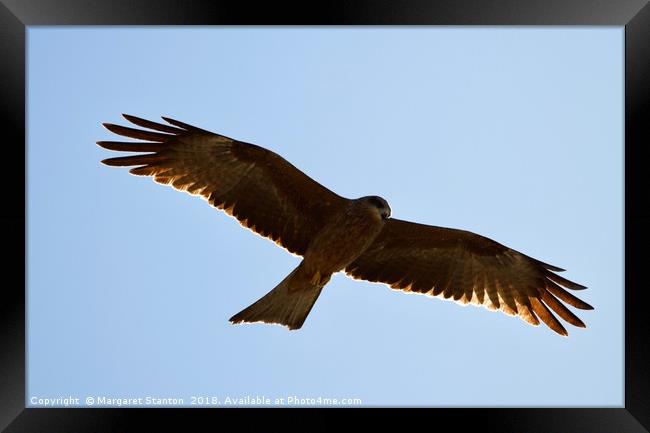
(345, 219, 593, 335)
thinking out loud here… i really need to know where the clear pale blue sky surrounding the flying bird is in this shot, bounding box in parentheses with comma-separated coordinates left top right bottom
(27, 27, 624, 407)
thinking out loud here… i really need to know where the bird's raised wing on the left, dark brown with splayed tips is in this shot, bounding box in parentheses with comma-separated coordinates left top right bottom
(97, 115, 347, 255)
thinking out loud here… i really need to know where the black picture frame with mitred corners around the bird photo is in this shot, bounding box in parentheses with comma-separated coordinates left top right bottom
(0, 0, 650, 433)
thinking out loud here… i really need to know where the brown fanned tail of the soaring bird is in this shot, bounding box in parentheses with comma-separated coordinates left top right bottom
(230, 266, 323, 330)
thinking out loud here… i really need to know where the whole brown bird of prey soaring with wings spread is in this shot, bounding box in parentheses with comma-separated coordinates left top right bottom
(97, 115, 593, 336)
